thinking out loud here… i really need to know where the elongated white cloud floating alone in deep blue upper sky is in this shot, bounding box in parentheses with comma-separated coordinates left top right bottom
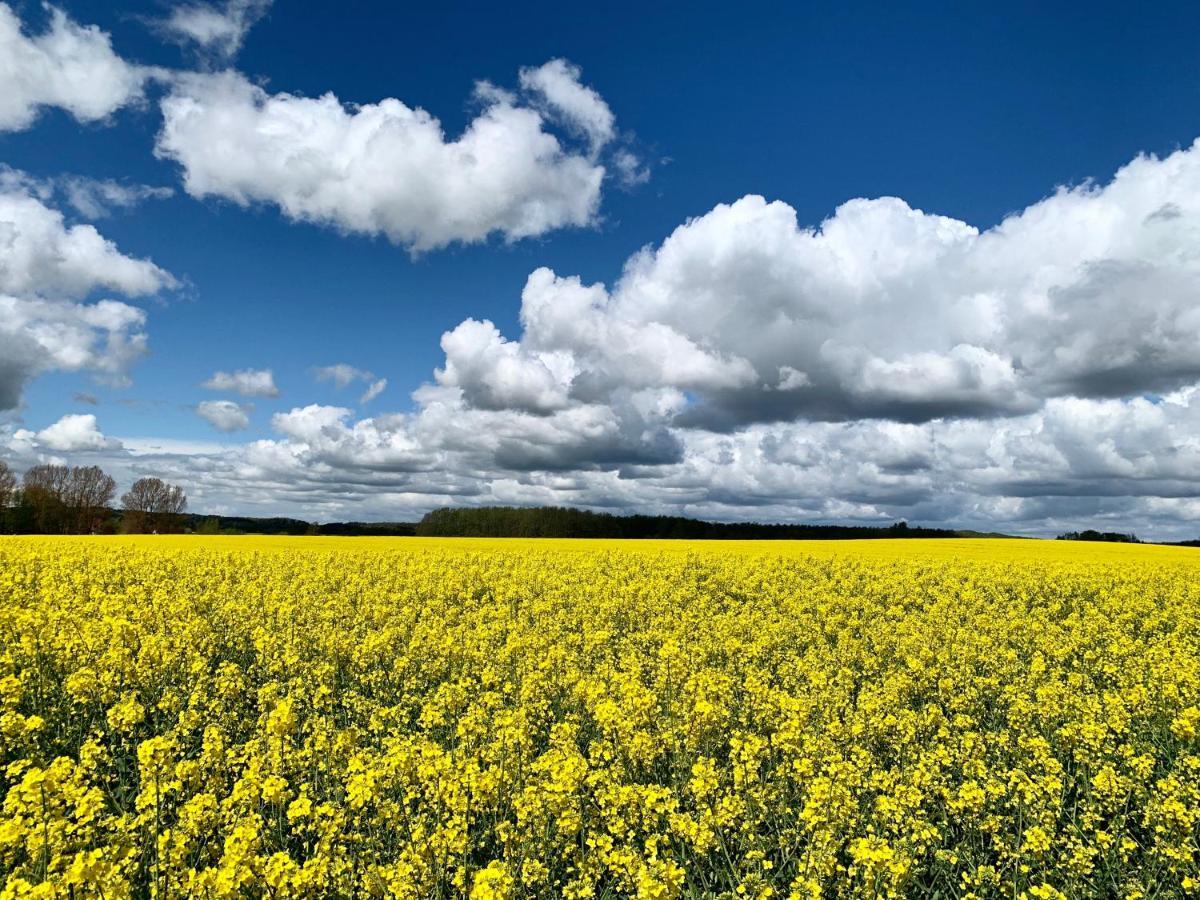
(156, 60, 628, 252)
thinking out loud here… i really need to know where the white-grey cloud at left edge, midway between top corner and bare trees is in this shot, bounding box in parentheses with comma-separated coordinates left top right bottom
(0, 180, 176, 409)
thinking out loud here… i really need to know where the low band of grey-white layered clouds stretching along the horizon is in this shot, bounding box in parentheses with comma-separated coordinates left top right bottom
(9, 388, 1200, 539)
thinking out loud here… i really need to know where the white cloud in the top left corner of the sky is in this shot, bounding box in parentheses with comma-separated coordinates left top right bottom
(0, 2, 148, 131)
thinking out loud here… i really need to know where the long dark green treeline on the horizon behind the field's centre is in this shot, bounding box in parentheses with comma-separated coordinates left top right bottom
(416, 506, 964, 540)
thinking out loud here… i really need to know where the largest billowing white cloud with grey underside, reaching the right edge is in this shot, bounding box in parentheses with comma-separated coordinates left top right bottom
(437, 144, 1200, 431)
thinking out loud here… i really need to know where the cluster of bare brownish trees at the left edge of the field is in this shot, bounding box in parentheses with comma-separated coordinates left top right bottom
(0, 460, 187, 534)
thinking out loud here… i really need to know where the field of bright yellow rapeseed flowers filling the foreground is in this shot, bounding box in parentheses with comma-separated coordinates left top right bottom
(0, 536, 1200, 900)
